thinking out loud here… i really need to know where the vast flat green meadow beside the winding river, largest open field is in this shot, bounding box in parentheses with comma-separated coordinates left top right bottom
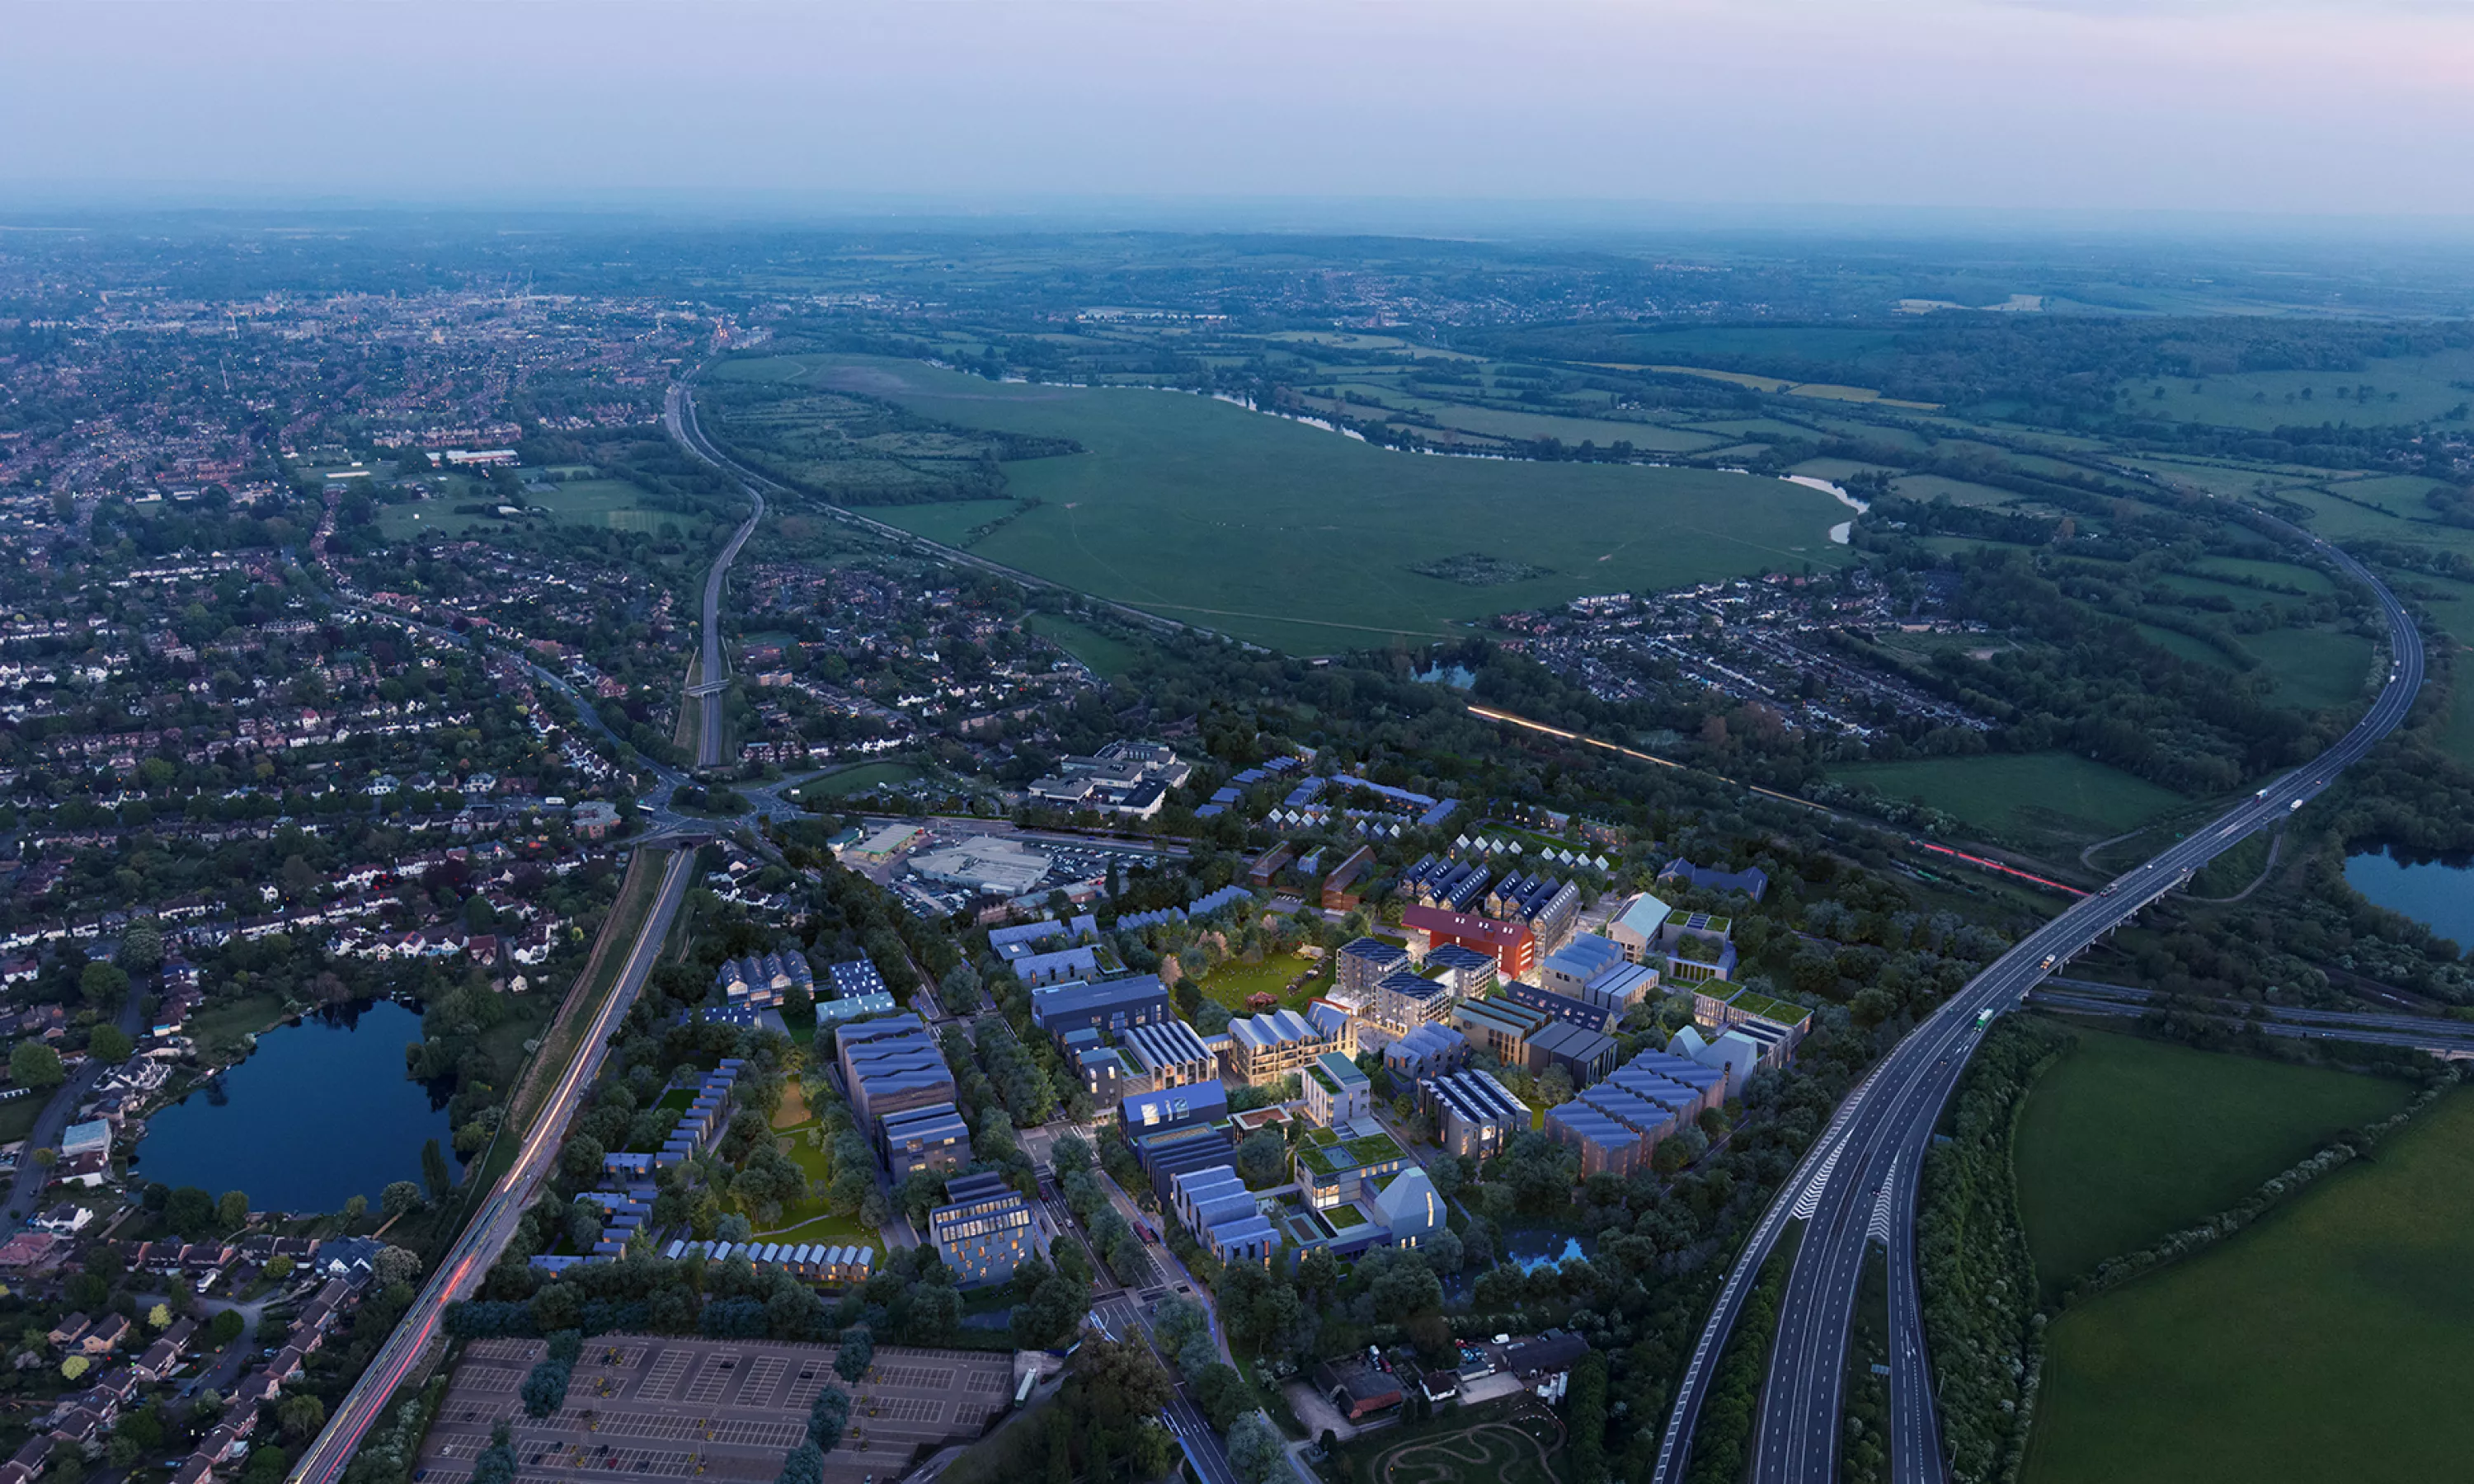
(715, 356, 1848, 653)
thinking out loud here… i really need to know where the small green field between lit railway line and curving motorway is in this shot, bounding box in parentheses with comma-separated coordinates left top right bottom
(1828, 752, 2185, 843)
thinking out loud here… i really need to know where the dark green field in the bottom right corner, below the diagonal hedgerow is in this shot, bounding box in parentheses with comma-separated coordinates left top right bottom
(2021, 1091, 2474, 1484)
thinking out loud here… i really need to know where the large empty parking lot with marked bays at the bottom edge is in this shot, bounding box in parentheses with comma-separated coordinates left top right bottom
(416, 1336, 1014, 1484)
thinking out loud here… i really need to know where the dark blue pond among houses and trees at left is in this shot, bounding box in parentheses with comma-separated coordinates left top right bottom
(131, 999, 455, 1212)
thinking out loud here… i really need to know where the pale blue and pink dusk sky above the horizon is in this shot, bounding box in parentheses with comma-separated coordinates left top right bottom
(14, 0, 2474, 218)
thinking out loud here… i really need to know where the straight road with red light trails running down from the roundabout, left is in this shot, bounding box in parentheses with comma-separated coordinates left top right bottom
(292, 851, 695, 1484)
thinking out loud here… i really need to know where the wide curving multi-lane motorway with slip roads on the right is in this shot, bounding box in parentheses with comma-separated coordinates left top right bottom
(1653, 527, 2425, 1484)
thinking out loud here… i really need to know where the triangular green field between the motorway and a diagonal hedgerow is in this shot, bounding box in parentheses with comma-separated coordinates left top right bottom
(2014, 1029, 2412, 1294)
